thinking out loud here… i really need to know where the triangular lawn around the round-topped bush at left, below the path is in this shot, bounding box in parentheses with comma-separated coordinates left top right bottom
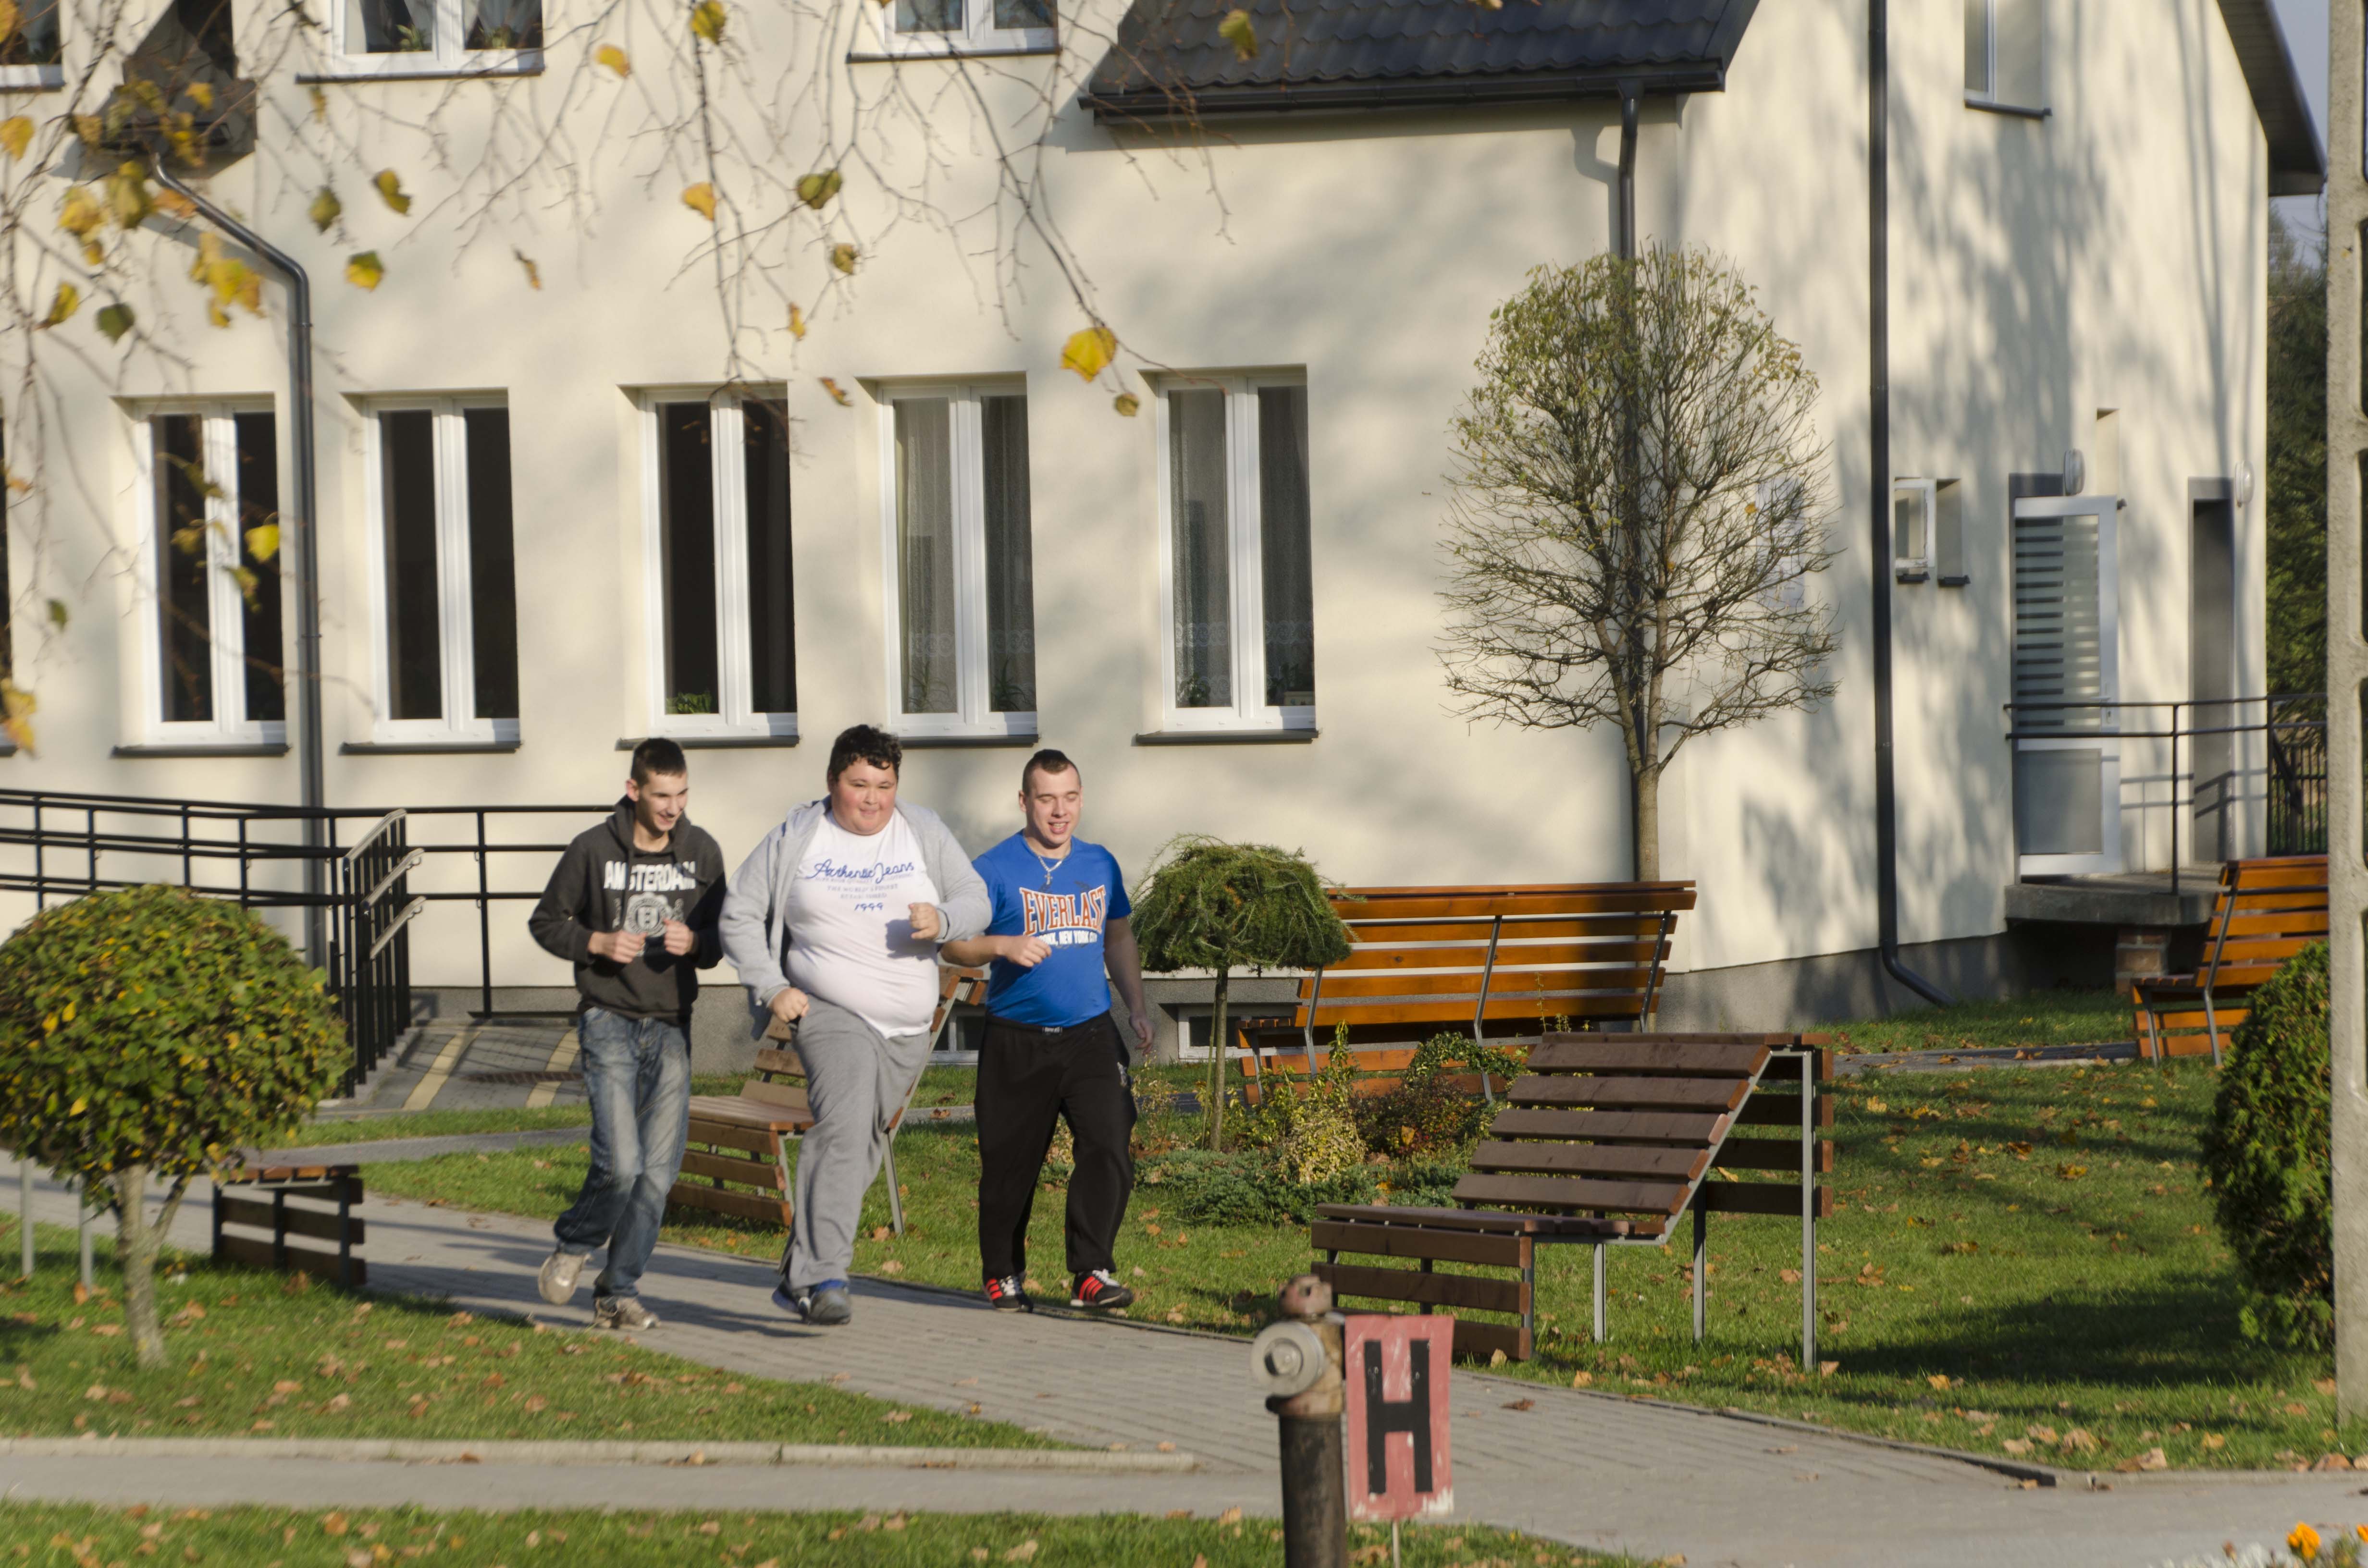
(0, 1217, 1056, 1447)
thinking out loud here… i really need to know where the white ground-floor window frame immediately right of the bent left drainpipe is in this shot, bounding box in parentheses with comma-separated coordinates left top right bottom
(362, 395, 518, 746)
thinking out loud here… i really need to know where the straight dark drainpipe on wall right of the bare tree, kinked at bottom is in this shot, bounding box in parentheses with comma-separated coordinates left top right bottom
(1866, 0, 1949, 1006)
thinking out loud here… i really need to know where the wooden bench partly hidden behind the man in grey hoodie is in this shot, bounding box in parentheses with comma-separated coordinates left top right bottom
(666, 969, 987, 1237)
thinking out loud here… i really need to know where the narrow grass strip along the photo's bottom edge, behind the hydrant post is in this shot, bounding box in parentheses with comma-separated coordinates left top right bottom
(0, 1504, 1634, 1568)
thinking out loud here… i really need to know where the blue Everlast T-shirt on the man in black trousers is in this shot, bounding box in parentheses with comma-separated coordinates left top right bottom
(971, 834, 1135, 1028)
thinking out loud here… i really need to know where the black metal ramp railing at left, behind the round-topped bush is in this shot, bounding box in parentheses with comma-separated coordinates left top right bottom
(0, 789, 611, 1090)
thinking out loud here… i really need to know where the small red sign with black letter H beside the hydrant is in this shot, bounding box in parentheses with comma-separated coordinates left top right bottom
(1343, 1312, 1456, 1518)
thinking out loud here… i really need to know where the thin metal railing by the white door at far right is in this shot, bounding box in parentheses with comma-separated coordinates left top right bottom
(2006, 692, 2328, 895)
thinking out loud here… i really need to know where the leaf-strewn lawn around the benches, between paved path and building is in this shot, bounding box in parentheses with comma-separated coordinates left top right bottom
(370, 1064, 2368, 1469)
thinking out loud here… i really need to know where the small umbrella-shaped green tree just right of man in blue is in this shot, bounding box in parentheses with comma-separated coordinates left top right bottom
(1132, 834, 1347, 1149)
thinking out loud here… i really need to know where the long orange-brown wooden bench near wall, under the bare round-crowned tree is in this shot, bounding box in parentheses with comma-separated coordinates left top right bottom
(1238, 881, 1693, 1106)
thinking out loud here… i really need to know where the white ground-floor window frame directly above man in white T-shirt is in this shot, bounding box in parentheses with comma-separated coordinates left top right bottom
(878, 379, 1042, 736)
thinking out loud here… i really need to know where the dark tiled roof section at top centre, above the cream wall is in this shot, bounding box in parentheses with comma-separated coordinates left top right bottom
(1080, 0, 1760, 119)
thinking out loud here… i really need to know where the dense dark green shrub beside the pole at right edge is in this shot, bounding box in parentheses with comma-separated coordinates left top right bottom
(2202, 943, 2335, 1348)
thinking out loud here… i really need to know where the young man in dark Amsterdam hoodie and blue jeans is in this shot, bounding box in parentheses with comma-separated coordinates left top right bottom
(526, 739, 725, 1329)
